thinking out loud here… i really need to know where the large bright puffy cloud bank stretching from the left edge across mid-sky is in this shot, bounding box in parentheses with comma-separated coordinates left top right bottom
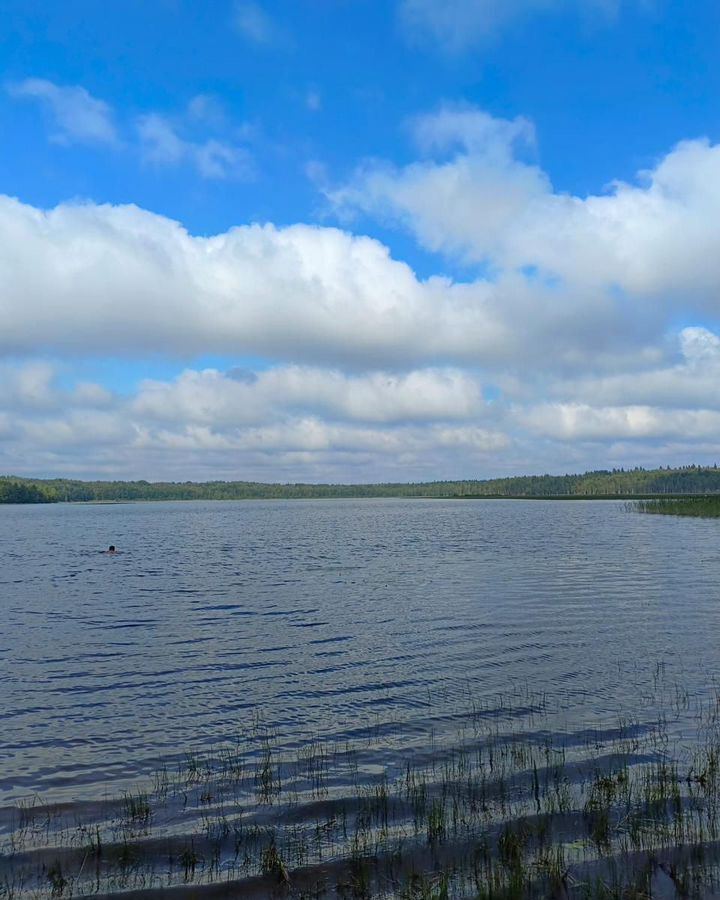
(0, 190, 692, 371)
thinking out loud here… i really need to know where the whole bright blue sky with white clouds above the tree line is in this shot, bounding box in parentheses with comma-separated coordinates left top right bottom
(0, 0, 720, 482)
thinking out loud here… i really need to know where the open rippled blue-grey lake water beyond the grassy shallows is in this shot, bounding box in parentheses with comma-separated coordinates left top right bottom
(0, 500, 720, 896)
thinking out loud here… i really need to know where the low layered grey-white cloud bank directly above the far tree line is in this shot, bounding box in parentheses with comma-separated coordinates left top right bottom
(0, 330, 720, 481)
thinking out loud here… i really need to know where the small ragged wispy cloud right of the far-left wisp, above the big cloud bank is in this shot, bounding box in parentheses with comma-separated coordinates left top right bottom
(138, 113, 252, 178)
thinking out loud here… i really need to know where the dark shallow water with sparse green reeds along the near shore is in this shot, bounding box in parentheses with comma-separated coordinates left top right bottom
(0, 680, 720, 900)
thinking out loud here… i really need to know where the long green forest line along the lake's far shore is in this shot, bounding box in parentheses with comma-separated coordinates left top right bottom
(0, 465, 720, 503)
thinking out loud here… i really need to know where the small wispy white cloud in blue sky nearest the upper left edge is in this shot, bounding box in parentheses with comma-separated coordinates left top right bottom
(8, 78, 118, 145)
